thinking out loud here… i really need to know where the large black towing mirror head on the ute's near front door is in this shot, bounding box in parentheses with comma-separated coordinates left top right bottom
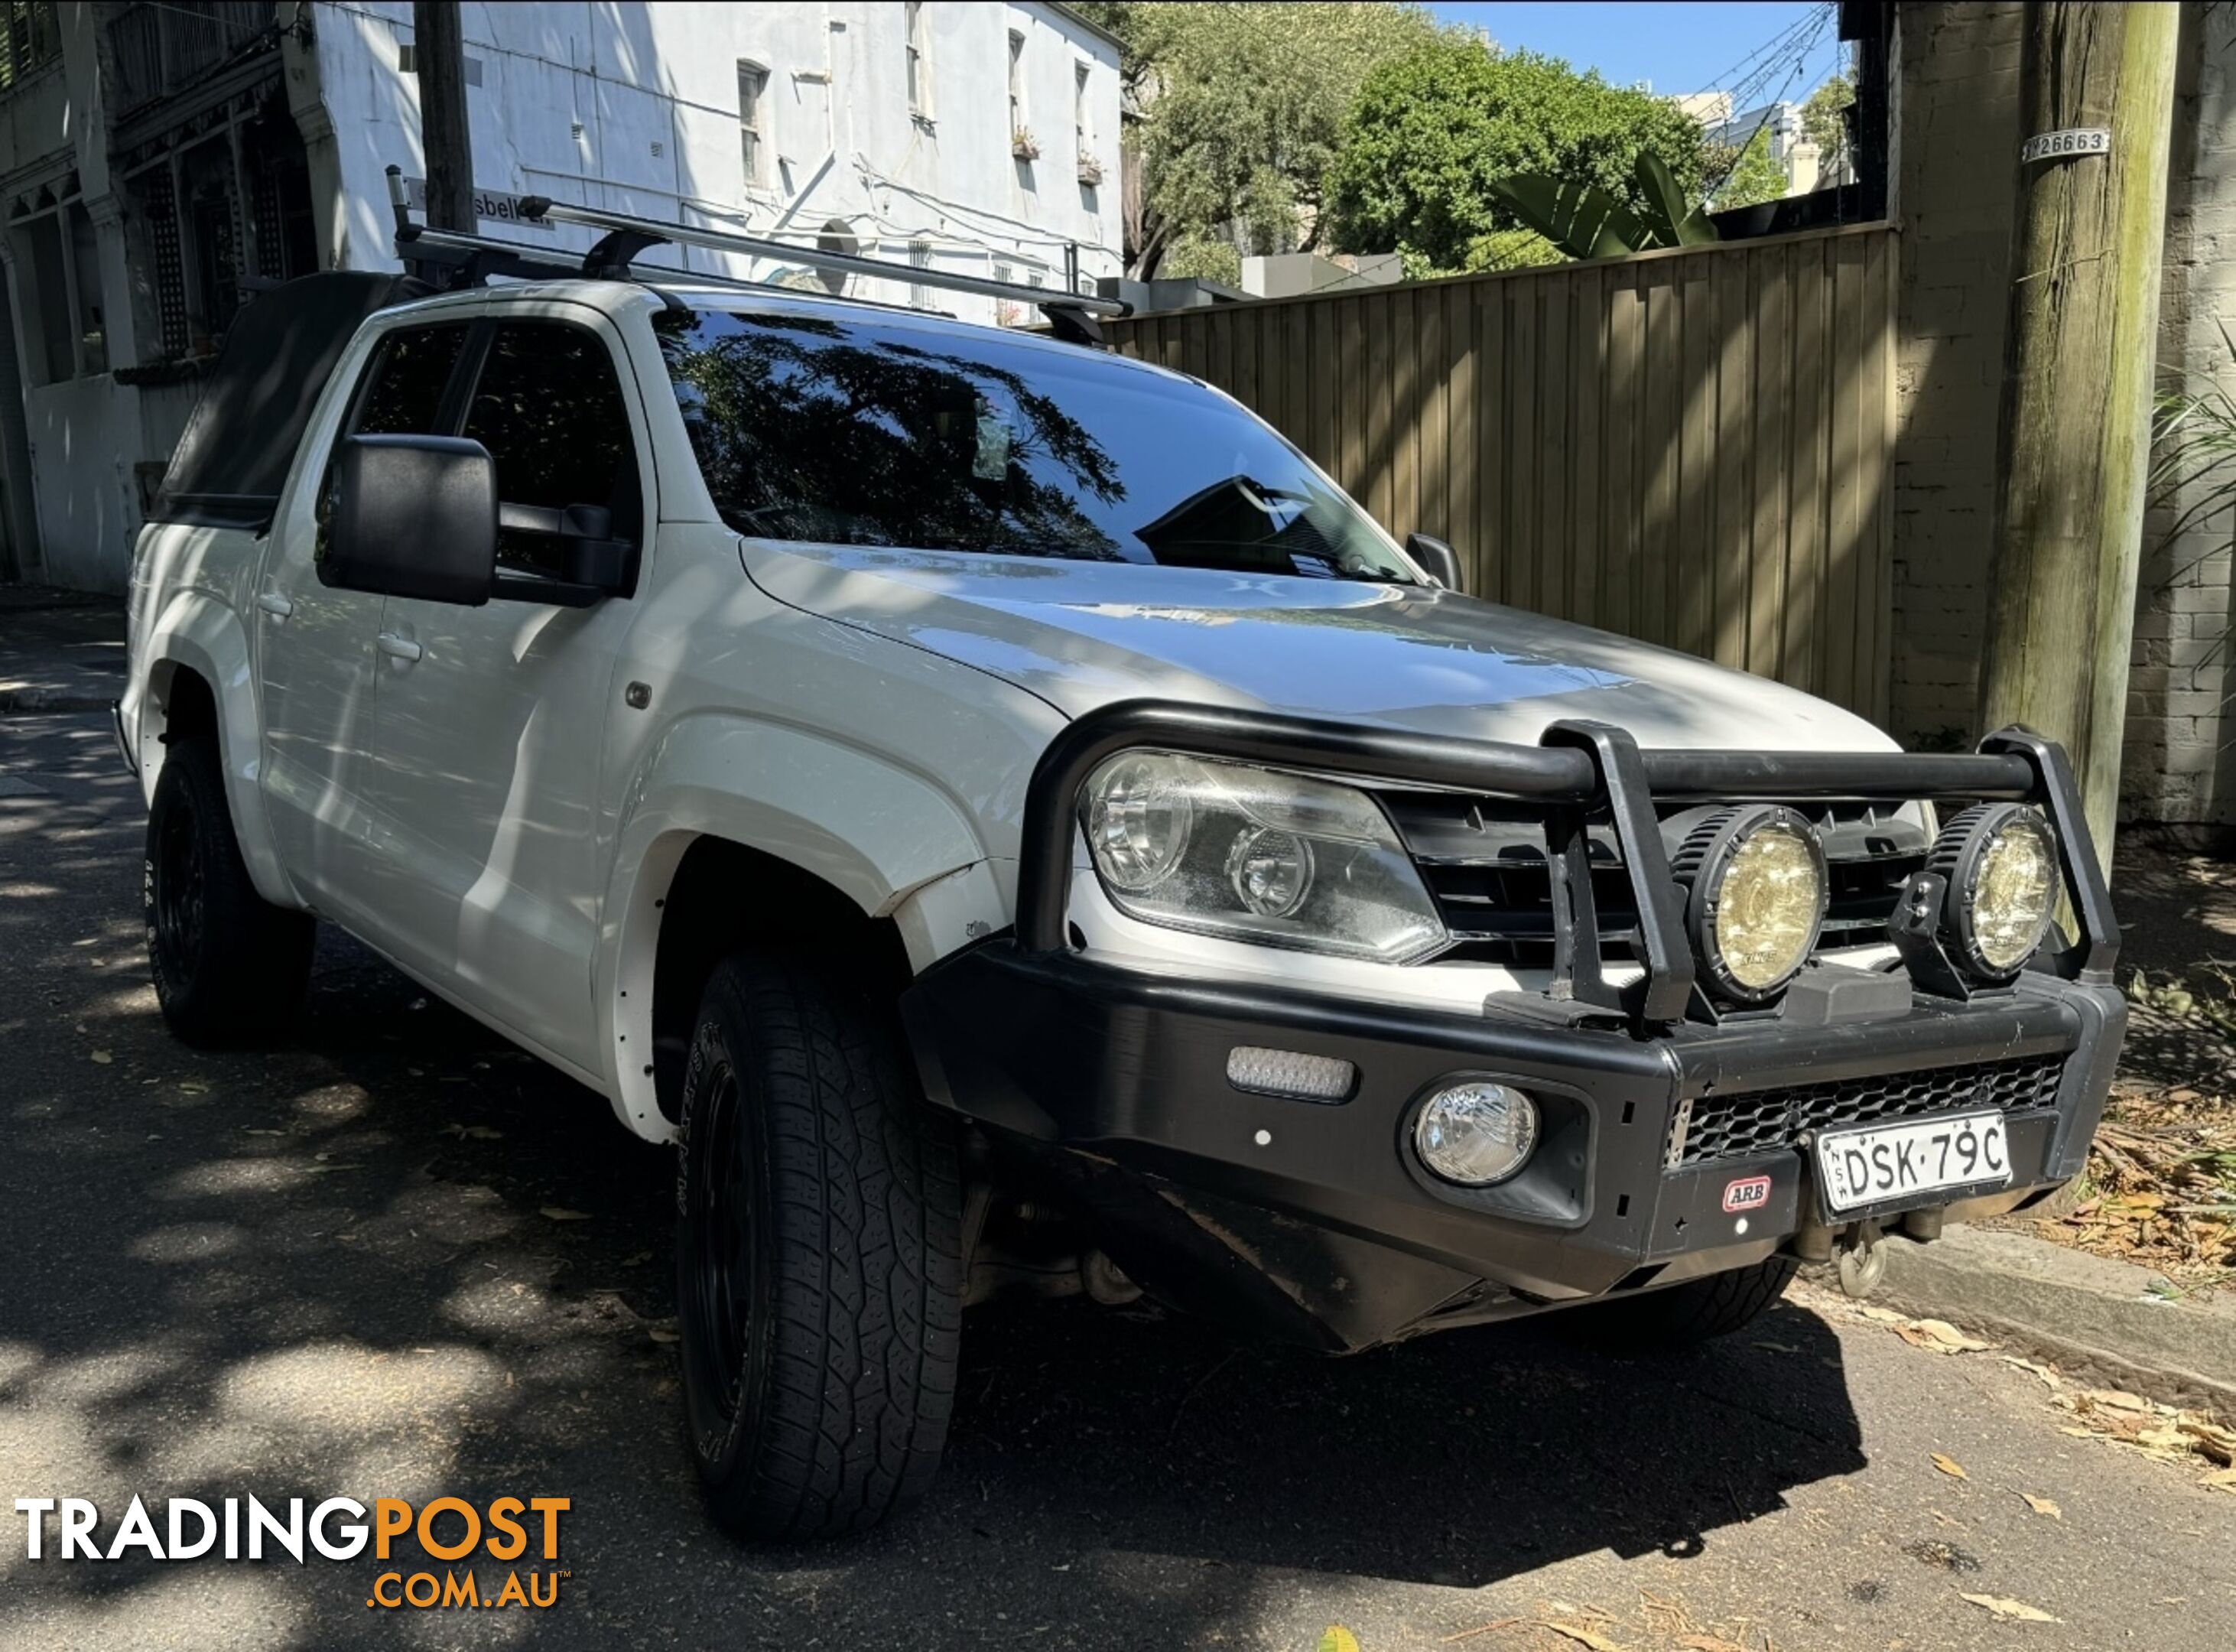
(317, 436, 496, 608)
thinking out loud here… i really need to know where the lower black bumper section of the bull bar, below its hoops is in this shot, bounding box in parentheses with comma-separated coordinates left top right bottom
(903, 941, 2127, 1348)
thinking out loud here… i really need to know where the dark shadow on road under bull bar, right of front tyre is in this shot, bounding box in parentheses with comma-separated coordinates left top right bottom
(908, 1303, 1865, 1587)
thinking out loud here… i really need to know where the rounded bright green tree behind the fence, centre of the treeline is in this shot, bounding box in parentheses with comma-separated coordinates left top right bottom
(1328, 31, 1708, 271)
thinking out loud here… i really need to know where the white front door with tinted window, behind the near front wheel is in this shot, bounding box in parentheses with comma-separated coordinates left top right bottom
(371, 304, 651, 1073)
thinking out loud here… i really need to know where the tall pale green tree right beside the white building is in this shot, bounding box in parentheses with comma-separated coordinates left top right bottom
(1080, 0, 1435, 279)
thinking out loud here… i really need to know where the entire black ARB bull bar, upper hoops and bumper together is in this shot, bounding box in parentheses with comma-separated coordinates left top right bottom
(903, 702, 2127, 1348)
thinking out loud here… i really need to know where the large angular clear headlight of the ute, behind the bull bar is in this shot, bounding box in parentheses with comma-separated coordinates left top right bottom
(1080, 751, 1447, 964)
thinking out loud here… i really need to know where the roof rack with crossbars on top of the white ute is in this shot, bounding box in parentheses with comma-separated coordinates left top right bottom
(389, 165, 1133, 344)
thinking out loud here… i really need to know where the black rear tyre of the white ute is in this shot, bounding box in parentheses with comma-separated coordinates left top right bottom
(141, 738, 317, 1044)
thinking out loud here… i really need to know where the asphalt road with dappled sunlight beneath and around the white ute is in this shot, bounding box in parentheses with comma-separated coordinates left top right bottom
(0, 715, 2236, 1652)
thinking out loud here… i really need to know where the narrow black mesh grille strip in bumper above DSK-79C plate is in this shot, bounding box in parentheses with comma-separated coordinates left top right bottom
(1668, 1055, 2064, 1169)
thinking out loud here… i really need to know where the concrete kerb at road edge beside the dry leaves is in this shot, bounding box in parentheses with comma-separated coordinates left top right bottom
(1874, 1228, 2236, 1417)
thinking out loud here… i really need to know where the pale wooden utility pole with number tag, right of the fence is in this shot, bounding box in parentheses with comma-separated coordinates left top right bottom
(1985, 0, 2180, 870)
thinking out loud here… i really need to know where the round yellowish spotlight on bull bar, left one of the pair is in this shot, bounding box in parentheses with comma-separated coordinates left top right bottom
(1670, 802, 1827, 1003)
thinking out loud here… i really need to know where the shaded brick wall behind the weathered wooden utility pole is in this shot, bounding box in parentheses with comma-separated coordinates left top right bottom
(1892, 0, 2236, 823)
